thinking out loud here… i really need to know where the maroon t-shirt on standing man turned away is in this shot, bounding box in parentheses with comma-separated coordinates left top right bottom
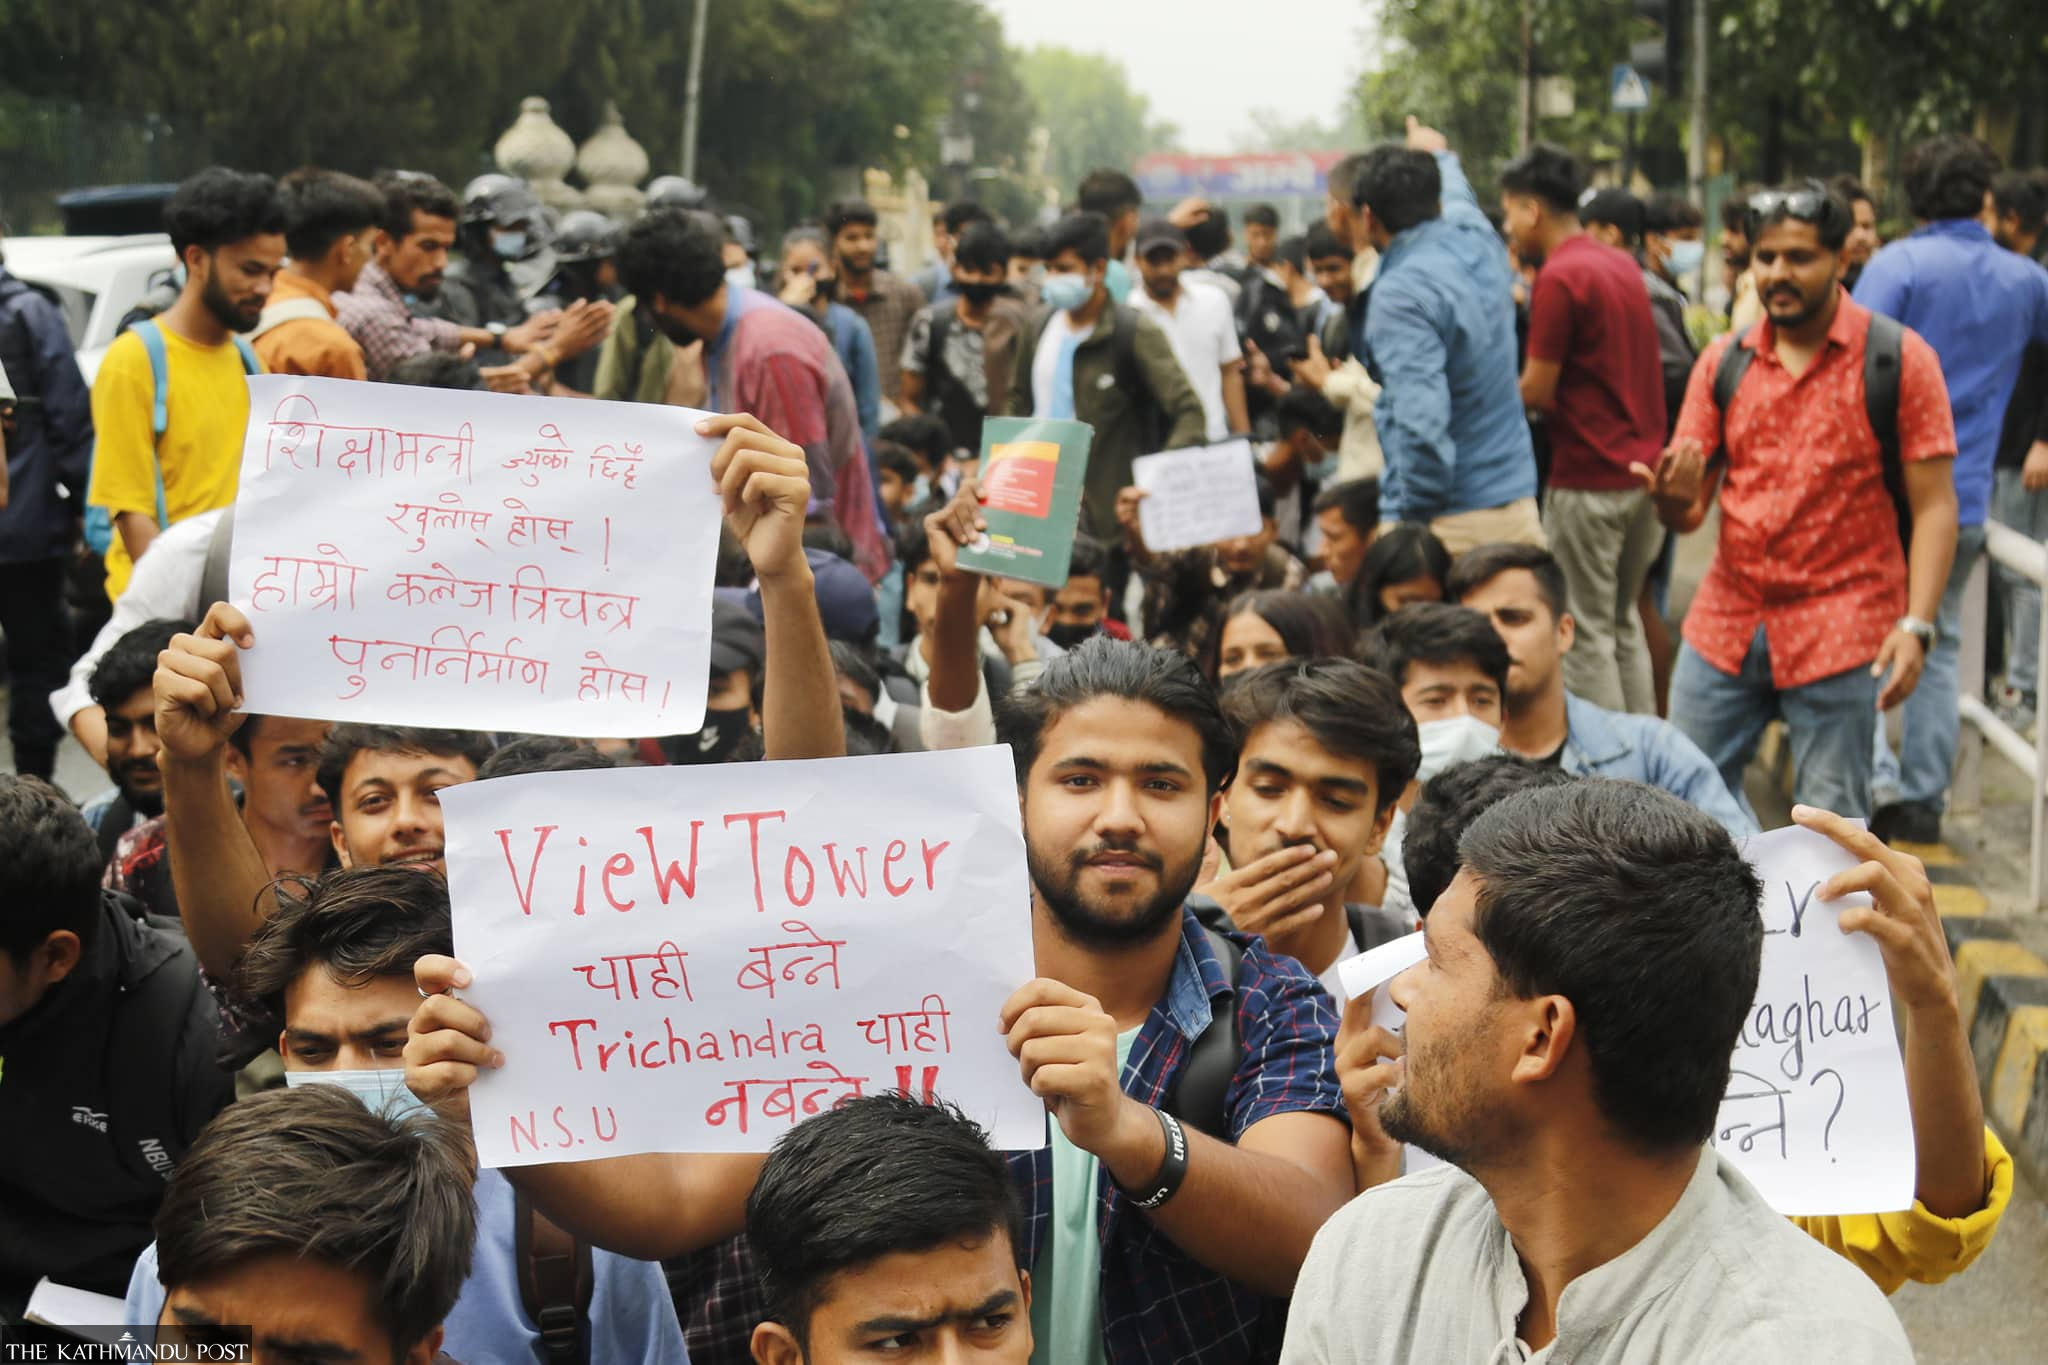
(1530, 233, 1665, 491)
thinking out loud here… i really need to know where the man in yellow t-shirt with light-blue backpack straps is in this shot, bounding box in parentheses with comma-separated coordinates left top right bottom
(86, 166, 285, 602)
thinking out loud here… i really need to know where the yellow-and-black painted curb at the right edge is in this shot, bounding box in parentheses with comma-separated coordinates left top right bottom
(1933, 916, 2048, 1189)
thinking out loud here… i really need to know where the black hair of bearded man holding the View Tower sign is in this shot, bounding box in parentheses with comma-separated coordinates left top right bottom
(995, 634, 1237, 792)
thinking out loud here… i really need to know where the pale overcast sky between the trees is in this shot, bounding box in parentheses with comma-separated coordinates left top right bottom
(987, 0, 1368, 151)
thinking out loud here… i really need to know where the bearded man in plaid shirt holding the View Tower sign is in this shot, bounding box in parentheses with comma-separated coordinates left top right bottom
(406, 639, 1352, 1365)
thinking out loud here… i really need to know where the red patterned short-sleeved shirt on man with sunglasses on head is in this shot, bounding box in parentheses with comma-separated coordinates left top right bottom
(1673, 295, 1956, 688)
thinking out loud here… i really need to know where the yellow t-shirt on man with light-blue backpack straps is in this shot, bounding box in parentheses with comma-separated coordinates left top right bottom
(86, 325, 250, 598)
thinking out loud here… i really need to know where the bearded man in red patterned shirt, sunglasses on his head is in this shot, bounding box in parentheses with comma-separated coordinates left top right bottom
(1636, 182, 1957, 817)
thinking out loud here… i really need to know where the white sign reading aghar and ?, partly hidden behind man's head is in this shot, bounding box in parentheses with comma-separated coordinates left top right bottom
(1714, 827, 1913, 1216)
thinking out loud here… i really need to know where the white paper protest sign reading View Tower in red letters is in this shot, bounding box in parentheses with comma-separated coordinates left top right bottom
(440, 747, 1044, 1166)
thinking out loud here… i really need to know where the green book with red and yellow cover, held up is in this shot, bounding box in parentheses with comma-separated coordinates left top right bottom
(961, 417, 1096, 587)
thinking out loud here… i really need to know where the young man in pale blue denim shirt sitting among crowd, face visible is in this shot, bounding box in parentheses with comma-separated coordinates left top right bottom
(1444, 544, 1757, 839)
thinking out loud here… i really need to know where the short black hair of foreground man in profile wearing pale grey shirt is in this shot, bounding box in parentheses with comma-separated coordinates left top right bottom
(1458, 778, 1763, 1152)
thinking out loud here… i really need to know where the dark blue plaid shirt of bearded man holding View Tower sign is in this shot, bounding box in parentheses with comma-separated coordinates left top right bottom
(672, 907, 1343, 1365)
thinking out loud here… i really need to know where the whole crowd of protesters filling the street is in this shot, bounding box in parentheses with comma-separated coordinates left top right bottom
(0, 109, 2048, 1365)
